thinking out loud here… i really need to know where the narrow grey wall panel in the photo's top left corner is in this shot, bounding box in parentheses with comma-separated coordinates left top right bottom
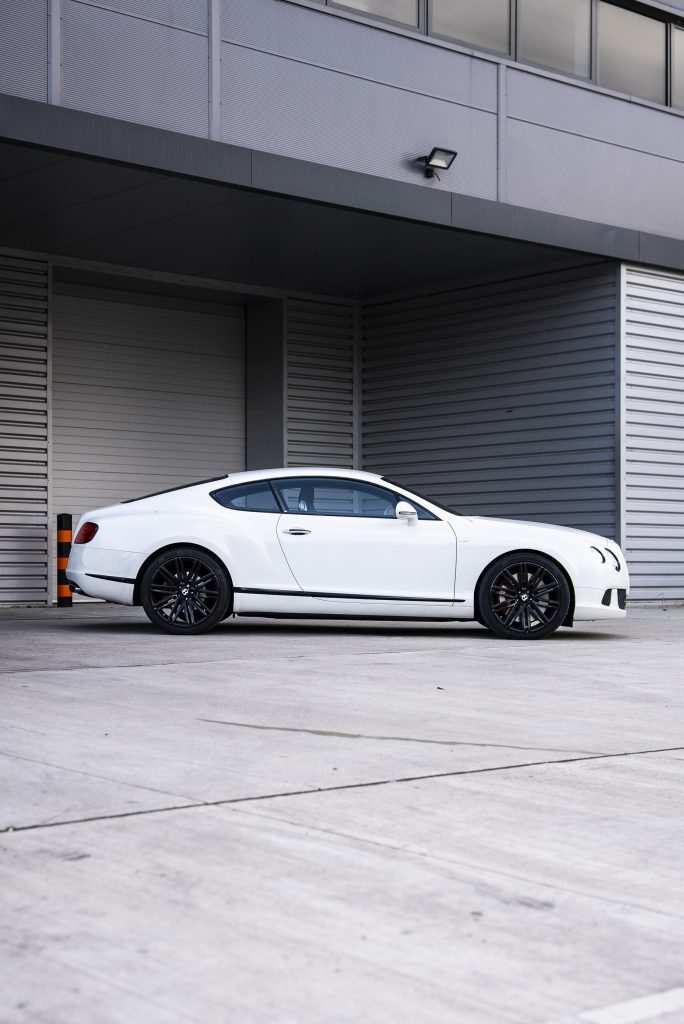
(0, 0, 47, 102)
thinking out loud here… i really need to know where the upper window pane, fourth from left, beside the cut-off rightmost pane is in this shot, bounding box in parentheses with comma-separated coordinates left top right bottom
(598, 0, 667, 103)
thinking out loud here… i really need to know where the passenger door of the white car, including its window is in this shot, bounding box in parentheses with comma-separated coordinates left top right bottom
(272, 476, 456, 602)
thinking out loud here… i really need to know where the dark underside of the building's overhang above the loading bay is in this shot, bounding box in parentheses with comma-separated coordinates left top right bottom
(0, 142, 587, 298)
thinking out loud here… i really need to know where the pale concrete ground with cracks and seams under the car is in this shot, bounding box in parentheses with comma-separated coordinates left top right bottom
(0, 605, 684, 1024)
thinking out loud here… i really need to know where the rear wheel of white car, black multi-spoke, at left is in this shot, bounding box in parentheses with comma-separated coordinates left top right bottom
(140, 547, 232, 636)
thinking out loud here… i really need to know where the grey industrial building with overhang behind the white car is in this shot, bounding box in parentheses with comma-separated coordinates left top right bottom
(0, 0, 684, 603)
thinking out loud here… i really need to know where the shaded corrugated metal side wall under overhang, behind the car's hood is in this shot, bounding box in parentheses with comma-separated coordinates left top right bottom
(362, 265, 617, 537)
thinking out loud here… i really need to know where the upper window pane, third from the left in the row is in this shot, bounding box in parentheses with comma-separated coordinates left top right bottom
(518, 0, 591, 78)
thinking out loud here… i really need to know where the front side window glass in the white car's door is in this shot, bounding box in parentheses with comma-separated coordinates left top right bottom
(272, 476, 437, 519)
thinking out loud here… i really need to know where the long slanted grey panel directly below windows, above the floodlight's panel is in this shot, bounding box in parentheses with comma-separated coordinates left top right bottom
(221, 0, 497, 113)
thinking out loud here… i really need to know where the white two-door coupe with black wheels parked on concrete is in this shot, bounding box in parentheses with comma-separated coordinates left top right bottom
(67, 469, 629, 640)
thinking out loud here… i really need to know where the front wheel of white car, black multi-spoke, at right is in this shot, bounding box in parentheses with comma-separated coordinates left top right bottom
(477, 551, 571, 640)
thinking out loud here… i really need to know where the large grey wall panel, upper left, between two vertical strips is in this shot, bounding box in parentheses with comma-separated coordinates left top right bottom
(62, 0, 209, 135)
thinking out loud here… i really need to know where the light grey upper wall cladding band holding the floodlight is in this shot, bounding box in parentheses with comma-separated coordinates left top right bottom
(0, 0, 684, 238)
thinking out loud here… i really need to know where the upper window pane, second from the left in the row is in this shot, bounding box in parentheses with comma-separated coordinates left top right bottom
(430, 0, 511, 53)
